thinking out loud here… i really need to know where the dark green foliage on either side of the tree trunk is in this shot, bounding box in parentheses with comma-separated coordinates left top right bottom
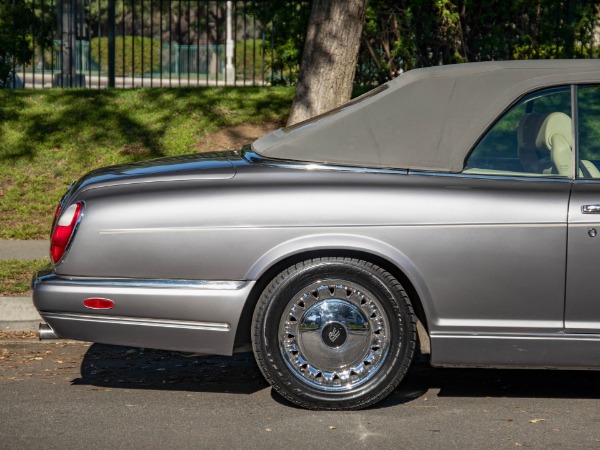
(247, 0, 600, 84)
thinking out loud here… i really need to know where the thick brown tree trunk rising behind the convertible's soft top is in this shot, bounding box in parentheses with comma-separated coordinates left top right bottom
(288, 0, 367, 125)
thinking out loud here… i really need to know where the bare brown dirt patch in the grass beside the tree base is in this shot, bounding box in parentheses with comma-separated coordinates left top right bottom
(196, 122, 282, 152)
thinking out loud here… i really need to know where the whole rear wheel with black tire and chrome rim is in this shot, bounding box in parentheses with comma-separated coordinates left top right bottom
(252, 258, 416, 410)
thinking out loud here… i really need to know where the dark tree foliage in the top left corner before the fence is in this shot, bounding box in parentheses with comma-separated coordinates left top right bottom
(0, 0, 50, 88)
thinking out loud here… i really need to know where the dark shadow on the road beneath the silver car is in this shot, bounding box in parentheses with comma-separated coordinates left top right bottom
(73, 344, 600, 408)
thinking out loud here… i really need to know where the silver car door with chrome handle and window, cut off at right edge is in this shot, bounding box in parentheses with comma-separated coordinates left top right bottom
(565, 86, 600, 333)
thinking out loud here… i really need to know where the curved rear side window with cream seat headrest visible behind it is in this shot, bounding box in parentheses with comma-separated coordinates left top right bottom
(463, 86, 573, 177)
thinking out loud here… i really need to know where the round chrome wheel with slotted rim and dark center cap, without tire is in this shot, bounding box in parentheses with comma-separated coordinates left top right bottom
(279, 279, 389, 391)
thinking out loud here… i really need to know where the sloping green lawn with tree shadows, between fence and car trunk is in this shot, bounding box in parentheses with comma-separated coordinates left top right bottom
(0, 87, 294, 239)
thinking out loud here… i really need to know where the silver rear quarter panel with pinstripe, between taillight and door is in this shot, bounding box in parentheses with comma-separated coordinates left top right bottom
(57, 165, 569, 338)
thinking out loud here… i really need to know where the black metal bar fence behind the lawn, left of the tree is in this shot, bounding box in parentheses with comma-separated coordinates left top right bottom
(13, 0, 286, 88)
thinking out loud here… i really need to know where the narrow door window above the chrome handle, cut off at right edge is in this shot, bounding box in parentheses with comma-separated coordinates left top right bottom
(577, 86, 600, 178)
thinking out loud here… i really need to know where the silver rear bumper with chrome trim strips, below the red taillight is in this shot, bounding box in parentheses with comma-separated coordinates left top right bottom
(33, 271, 254, 355)
